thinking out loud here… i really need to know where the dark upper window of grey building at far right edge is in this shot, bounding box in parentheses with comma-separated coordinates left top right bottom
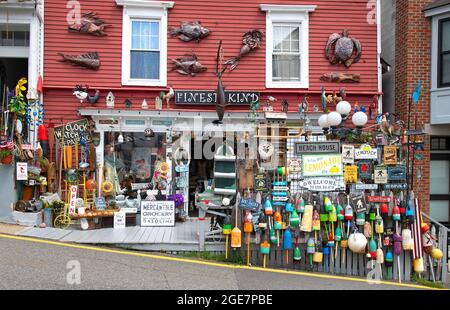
(438, 18, 450, 87)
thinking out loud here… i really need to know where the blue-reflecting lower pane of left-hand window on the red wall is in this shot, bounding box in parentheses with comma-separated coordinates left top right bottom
(130, 51, 160, 80)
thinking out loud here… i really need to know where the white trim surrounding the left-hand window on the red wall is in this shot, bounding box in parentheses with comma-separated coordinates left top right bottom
(116, 0, 174, 87)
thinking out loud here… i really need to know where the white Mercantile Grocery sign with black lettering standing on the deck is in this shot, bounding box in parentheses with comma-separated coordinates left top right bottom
(141, 201, 175, 227)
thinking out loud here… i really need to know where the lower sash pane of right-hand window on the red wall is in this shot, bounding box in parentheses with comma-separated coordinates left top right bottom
(272, 55, 300, 81)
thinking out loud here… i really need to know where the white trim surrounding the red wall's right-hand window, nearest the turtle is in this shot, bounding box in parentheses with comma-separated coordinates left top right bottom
(260, 4, 317, 88)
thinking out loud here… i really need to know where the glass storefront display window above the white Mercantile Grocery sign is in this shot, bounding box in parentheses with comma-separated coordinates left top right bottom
(104, 132, 168, 192)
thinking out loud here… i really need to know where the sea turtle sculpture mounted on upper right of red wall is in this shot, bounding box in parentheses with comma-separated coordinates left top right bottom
(325, 29, 362, 68)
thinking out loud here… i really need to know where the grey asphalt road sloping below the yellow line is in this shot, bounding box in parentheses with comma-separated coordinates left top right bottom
(0, 235, 428, 290)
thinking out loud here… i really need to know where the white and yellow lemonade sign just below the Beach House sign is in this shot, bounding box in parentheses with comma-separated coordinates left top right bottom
(302, 154, 344, 177)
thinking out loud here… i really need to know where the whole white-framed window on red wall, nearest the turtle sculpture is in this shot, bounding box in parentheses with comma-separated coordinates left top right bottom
(260, 4, 316, 88)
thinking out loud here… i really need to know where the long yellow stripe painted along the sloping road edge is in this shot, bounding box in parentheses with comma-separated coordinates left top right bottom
(0, 234, 448, 290)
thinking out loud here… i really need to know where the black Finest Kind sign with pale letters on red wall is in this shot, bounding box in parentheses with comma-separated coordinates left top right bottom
(175, 90, 260, 105)
